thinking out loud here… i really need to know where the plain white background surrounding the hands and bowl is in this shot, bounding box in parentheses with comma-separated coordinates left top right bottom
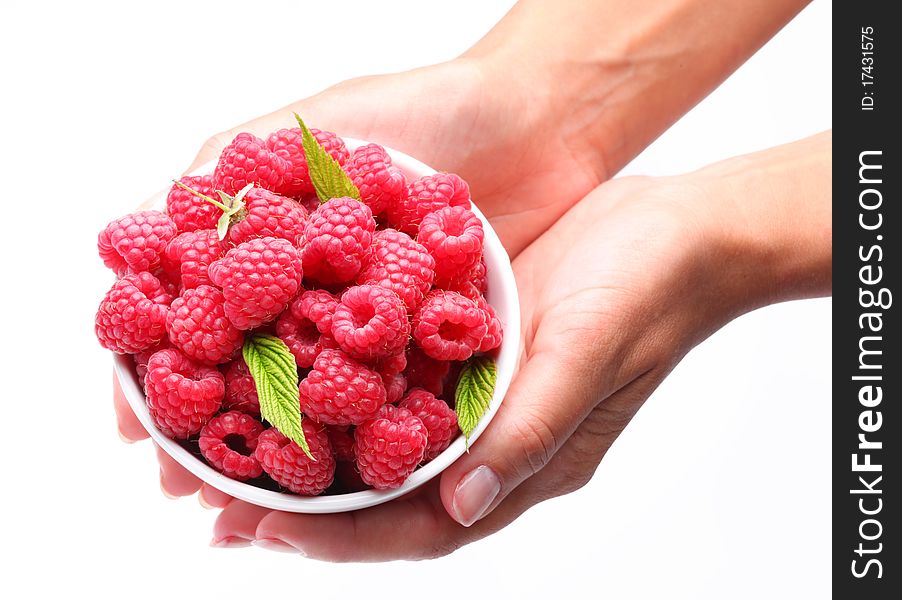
(0, 0, 832, 598)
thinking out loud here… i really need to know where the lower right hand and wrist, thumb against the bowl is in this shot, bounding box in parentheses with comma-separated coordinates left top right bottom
(207, 134, 832, 561)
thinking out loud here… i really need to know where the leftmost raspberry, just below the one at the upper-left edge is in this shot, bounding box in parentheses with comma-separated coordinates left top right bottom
(94, 273, 172, 354)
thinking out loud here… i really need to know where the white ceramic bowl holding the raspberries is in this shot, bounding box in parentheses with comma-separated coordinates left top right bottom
(114, 138, 520, 513)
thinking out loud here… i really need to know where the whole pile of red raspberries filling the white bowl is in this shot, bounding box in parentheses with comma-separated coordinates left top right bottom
(95, 128, 502, 496)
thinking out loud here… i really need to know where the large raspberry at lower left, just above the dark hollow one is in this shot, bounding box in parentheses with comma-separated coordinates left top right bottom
(144, 348, 225, 439)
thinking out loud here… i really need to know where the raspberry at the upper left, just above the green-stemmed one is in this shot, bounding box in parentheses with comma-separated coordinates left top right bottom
(213, 133, 291, 195)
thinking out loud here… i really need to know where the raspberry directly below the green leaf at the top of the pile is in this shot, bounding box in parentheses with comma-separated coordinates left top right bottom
(303, 198, 376, 284)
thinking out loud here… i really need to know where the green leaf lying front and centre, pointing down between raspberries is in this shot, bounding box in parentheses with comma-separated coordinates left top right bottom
(242, 333, 316, 460)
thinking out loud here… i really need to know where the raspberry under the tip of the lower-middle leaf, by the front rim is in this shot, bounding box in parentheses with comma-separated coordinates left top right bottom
(254, 419, 335, 496)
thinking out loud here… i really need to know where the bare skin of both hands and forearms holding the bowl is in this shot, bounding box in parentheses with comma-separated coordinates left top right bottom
(114, 0, 832, 561)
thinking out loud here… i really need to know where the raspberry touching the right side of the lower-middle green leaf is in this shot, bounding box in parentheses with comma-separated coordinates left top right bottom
(300, 350, 385, 425)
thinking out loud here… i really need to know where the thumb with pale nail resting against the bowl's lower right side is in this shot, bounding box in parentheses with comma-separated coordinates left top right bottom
(440, 350, 599, 527)
